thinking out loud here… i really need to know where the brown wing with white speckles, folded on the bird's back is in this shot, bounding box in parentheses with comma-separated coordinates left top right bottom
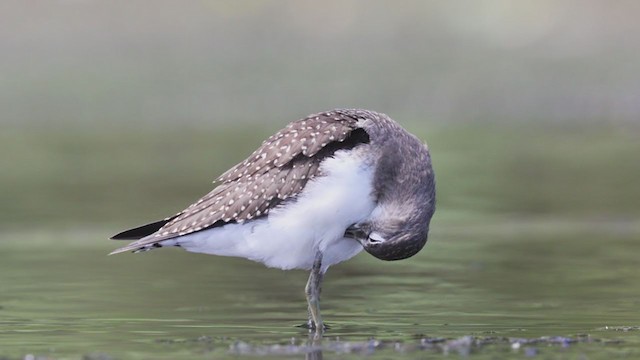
(114, 111, 369, 253)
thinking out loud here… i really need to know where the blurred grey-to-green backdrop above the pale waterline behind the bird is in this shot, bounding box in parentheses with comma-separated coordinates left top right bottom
(0, 0, 640, 230)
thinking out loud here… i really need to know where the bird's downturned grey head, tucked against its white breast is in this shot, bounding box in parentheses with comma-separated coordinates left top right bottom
(345, 201, 433, 261)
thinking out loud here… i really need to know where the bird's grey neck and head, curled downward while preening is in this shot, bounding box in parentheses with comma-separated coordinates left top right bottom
(346, 116, 435, 260)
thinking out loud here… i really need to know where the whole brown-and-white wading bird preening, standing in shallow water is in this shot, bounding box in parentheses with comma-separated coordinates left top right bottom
(110, 109, 436, 332)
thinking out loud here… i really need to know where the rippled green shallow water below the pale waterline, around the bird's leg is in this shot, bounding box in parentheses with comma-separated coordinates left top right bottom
(0, 218, 640, 359)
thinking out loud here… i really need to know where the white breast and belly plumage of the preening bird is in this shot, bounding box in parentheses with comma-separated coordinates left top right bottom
(170, 151, 375, 271)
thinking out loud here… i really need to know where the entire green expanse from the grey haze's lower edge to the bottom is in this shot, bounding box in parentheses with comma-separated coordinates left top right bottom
(0, 124, 640, 360)
